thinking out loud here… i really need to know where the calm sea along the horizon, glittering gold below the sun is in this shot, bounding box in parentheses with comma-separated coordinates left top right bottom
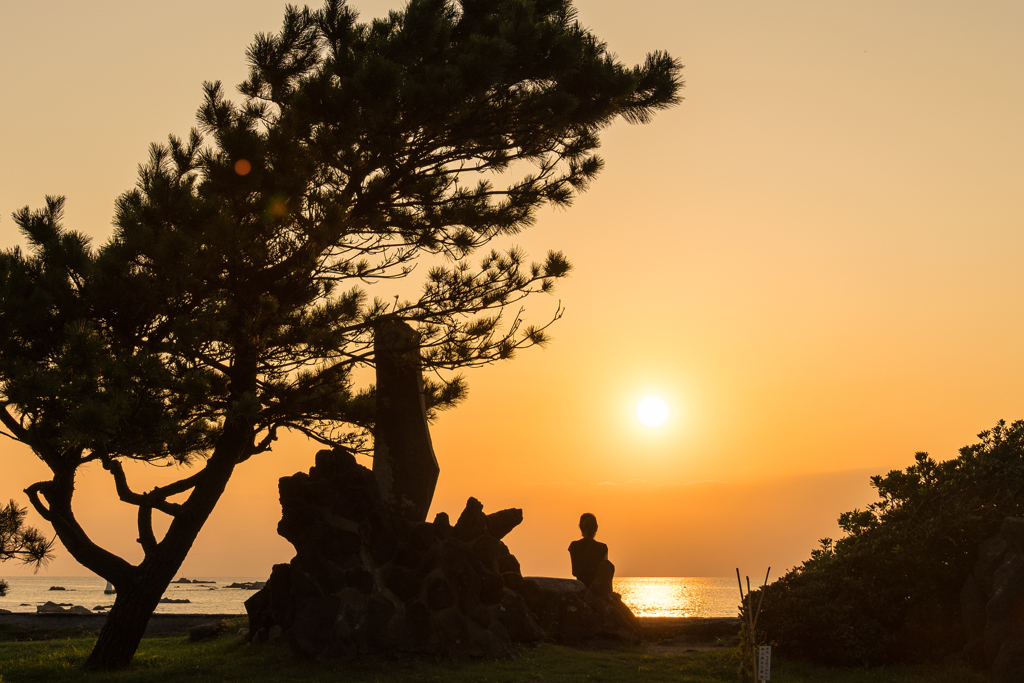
(0, 577, 739, 616)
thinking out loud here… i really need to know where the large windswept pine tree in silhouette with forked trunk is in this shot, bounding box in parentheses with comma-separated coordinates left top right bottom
(0, 0, 681, 668)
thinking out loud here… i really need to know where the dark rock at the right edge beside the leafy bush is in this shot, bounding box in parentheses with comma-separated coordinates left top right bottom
(961, 517, 1024, 683)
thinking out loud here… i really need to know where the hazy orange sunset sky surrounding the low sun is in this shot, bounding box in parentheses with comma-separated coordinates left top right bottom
(0, 0, 1024, 577)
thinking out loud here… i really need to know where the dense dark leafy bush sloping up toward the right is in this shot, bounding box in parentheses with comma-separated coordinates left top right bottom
(758, 421, 1024, 665)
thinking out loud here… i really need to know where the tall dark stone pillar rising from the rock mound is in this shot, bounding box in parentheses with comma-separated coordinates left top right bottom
(374, 317, 440, 521)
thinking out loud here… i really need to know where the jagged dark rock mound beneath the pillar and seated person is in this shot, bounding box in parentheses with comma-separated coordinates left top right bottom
(246, 450, 638, 660)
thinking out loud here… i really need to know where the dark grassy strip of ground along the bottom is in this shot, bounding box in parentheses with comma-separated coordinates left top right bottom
(0, 632, 985, 683)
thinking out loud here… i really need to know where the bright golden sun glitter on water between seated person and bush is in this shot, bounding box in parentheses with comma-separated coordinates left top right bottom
(614, 577, 739, 616)
